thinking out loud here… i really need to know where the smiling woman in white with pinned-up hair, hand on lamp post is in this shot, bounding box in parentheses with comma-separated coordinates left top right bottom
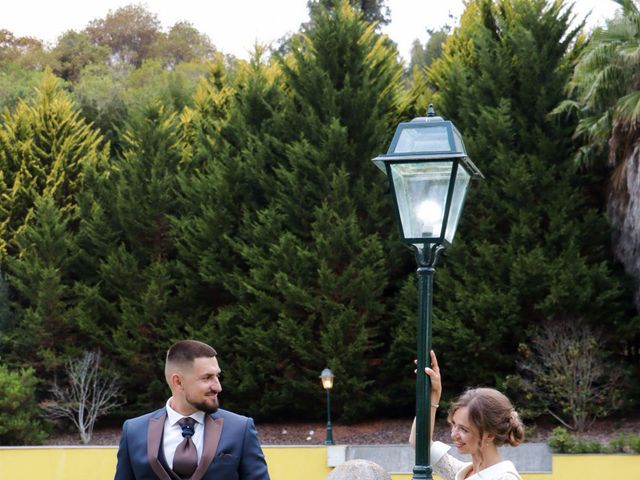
(409, 351, 524, 480)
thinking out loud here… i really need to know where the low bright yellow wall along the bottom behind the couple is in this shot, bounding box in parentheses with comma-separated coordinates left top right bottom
(0, 447, 640, 480)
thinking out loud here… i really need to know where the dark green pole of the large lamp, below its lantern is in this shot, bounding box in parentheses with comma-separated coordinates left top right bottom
(413, 244, 444, 480)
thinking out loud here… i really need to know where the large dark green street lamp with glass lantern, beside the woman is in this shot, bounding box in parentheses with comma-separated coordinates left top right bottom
(373, 105, 482, 479)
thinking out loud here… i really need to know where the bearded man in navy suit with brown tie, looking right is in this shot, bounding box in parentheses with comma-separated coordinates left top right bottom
(115, 340, 269, 480)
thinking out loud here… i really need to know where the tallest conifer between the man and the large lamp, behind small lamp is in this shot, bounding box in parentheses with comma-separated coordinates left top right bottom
(216, 2, 401, 419)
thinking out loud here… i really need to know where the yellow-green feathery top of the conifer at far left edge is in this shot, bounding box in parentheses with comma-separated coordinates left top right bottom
(0, 72, 103, 259)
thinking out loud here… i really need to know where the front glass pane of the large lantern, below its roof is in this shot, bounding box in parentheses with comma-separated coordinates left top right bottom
(389, 161, 453, 239)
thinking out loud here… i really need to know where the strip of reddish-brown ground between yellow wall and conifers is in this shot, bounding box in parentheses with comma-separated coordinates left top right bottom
(45, 415, 640, 445)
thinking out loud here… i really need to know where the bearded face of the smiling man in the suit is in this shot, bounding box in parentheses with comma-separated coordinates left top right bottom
(183, 357, 222, 413)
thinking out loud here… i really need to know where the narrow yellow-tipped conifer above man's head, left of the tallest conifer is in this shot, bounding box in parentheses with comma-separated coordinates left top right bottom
(172, 50, 284, 326)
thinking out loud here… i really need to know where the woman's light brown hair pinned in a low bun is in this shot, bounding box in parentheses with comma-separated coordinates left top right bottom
(448, 388, 524, 447)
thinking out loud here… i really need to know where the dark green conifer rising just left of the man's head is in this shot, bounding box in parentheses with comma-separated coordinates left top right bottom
(78, 102, 191, 409)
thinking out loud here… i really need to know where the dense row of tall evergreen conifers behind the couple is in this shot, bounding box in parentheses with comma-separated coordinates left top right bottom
(0, 0, 640, 442)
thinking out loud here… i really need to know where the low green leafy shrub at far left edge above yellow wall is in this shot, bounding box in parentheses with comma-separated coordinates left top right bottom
(0, 364, 45, 445)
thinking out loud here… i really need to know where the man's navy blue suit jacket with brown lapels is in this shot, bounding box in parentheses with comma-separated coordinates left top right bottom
(115, 408, 269, 480)
